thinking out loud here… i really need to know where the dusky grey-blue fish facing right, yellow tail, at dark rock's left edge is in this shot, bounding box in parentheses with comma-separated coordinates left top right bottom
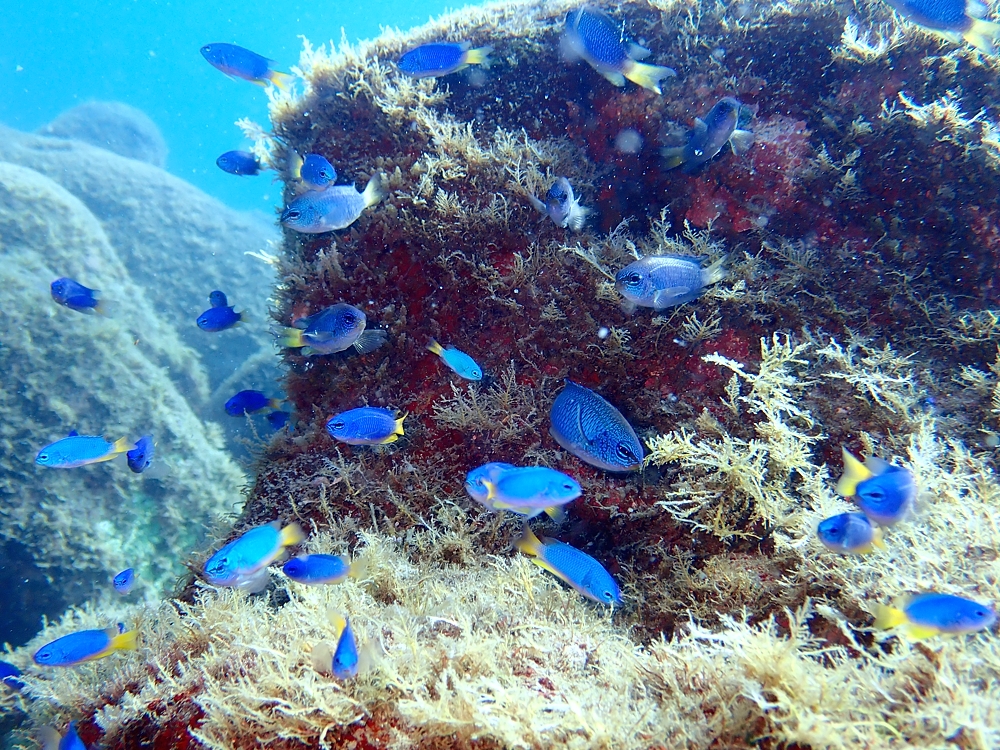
(274, 302, 388, 357)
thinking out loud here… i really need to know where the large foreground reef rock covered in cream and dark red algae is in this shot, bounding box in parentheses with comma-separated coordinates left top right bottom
(1, 2, 1000, 748)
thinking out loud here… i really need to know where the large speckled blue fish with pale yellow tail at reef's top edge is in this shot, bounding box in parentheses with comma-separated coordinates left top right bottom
(560, 6, 677, 94)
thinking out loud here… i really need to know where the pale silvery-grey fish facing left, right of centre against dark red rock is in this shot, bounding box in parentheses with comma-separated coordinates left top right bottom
(615, 255, 728, 310)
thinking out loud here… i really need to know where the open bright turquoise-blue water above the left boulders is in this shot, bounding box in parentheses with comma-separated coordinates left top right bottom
(0, 0, 445, 213)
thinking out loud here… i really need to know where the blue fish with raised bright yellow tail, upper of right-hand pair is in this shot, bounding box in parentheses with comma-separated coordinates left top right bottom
(837, 448, 917, 526)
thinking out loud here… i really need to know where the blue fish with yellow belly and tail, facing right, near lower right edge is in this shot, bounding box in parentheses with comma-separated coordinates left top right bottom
(875, 593, 997, 640)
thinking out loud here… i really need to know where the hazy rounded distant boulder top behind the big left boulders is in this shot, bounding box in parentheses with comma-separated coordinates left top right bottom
(38, 101, 167, 168)
